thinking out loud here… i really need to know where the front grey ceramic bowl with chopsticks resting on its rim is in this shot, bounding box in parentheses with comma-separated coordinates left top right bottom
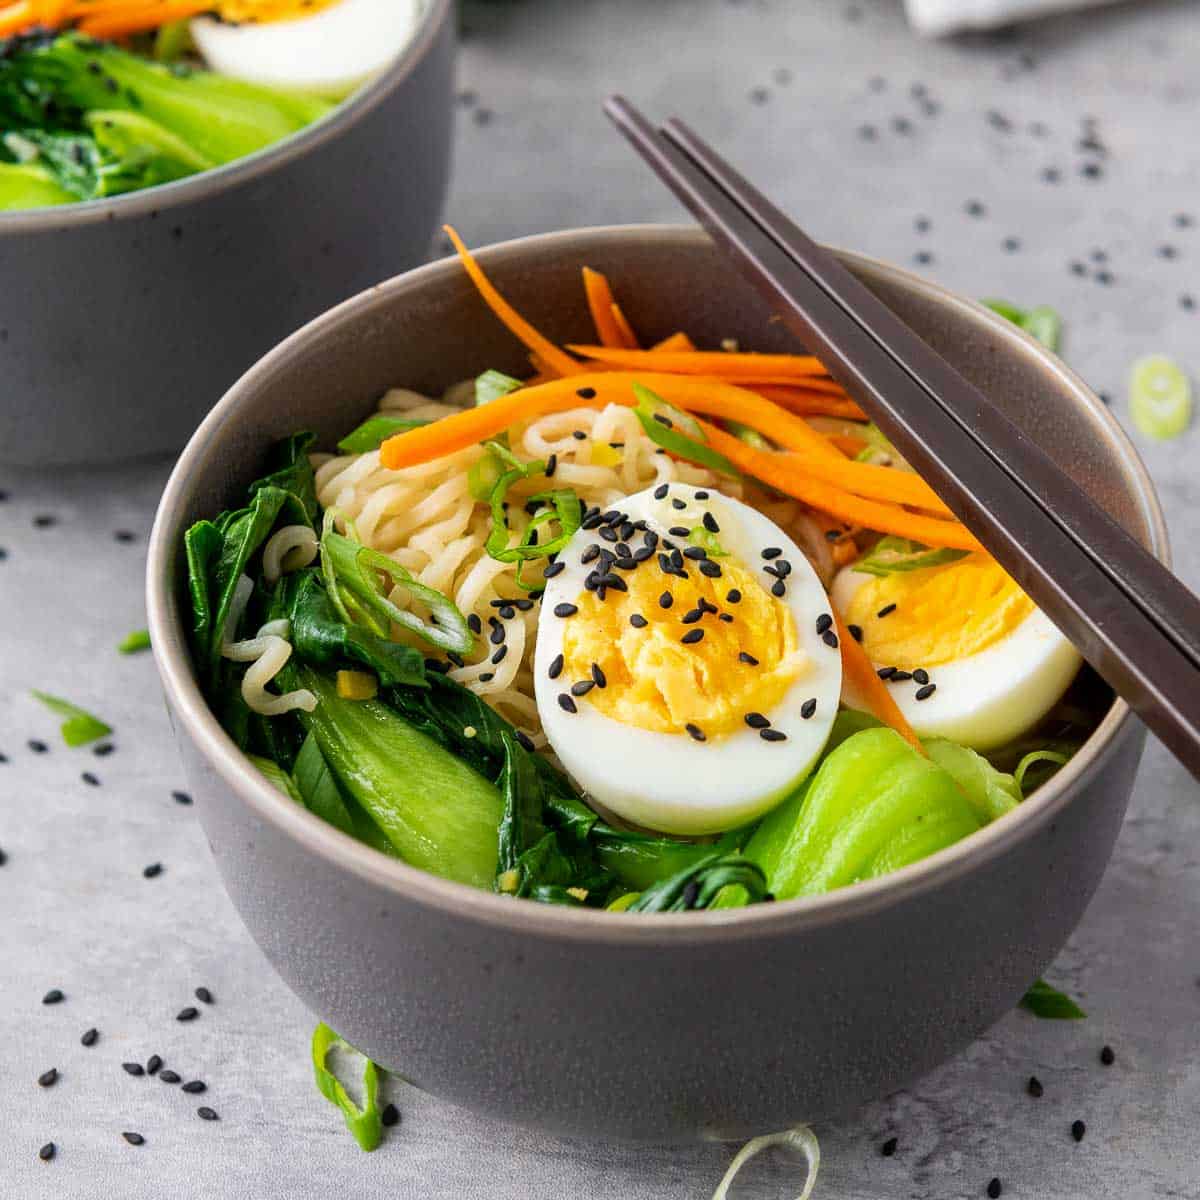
(148, 227, 1165, 1140)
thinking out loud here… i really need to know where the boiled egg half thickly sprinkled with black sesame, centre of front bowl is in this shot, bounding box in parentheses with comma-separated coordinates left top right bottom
(534, 484, 841, 834)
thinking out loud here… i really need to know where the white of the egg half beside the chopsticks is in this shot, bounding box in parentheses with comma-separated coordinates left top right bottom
(830, 566, 1084, 751)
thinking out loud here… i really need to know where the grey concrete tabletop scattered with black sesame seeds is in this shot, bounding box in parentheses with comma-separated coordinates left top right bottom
(0, 0, 1200, 1200)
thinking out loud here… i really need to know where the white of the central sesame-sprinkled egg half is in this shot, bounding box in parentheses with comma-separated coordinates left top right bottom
(534, 484, 841, 835)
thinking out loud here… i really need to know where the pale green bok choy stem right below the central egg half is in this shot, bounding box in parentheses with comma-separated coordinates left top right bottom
(745, 727, 984, 900)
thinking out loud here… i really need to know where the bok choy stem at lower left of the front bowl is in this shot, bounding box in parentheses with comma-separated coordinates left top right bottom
(292, 662, 504, 888)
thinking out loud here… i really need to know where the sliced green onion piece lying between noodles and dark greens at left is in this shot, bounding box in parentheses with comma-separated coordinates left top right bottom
(320, 509, 475, 654)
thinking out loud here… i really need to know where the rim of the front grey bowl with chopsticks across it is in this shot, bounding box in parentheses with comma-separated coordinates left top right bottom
(146, 224, 1170, 947)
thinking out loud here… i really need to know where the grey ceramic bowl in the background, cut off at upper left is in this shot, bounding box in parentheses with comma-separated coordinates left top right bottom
(0, 0, 454, 466)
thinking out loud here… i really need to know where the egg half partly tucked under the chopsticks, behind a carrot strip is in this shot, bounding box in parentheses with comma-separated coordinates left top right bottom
(832, 554, 1082, 750)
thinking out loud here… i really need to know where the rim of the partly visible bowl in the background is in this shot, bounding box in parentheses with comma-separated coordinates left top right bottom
(0, 0, 454, 236)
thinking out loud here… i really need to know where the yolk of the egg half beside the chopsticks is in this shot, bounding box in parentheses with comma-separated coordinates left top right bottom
(842, 554, 1033, 671)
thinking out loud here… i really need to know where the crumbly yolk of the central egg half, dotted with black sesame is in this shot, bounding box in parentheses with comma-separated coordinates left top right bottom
(563, 557, 804, 739)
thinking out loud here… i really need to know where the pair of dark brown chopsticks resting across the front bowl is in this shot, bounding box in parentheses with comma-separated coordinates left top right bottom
(605, 96, 1200, 778)
